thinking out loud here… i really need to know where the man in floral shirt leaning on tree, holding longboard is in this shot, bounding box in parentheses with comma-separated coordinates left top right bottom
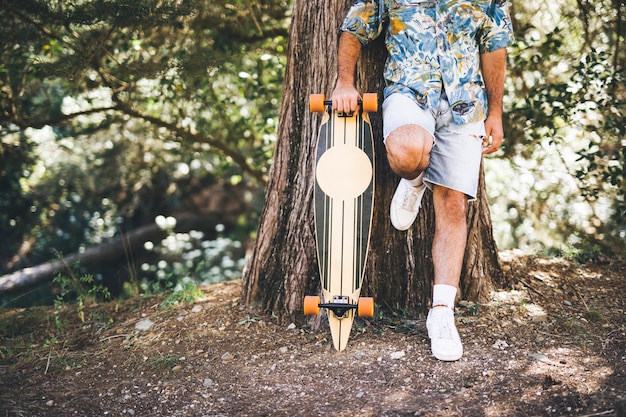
(332, 0, 513, 361)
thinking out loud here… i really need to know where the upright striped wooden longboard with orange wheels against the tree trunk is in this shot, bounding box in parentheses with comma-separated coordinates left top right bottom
(304, 94, 378, 351)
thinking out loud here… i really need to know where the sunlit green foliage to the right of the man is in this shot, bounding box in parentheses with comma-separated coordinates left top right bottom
(487, 0, 626, 256)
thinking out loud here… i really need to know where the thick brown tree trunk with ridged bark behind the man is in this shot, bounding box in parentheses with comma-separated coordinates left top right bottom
(242, 0, 502, 321)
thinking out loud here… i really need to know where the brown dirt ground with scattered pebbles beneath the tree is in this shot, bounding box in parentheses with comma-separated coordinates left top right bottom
(0, 253, 626, 417)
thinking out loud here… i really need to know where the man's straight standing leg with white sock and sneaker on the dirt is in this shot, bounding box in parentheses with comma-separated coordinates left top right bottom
(426, 186, 467, 361)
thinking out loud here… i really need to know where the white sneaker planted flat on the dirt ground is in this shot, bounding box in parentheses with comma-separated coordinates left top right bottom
(426, 306, 463, 361)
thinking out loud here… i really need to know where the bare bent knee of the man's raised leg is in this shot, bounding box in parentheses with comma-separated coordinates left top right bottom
(385, 125, 433, 178)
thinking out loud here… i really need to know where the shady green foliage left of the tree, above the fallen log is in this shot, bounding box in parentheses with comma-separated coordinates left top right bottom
(0, 0, 290, 294)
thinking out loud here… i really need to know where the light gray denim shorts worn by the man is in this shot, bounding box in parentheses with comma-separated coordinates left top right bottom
(383, 93, 485, 200)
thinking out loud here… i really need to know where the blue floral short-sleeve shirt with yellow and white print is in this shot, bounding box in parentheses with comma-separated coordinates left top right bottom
(341, 0, 513, 123)
